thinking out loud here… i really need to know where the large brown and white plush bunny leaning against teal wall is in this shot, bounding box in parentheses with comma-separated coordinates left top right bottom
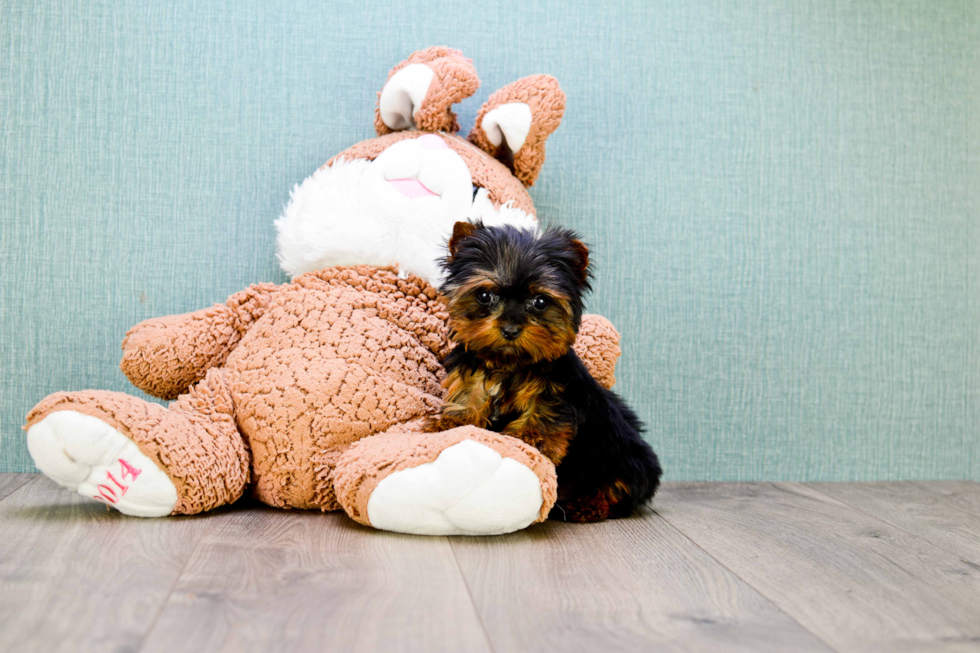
(25, 47, 619, 535)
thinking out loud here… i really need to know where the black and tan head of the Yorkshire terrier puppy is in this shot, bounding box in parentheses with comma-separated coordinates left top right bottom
(440, 222, 591, 363)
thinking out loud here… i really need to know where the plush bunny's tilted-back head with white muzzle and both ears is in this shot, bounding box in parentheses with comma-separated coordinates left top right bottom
(276, 47, 565, 285)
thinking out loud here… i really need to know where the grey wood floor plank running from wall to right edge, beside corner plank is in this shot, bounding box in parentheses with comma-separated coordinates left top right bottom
(806, 482, 980, 564)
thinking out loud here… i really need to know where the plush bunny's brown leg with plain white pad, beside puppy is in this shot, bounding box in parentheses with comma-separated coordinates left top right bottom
(334, 426, 558, 535)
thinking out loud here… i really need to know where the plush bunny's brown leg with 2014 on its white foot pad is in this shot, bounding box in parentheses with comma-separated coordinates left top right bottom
(25, 370, 249, 517)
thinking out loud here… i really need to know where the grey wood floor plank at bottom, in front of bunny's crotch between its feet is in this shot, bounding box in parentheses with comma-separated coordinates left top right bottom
(143, 507, 490, 653)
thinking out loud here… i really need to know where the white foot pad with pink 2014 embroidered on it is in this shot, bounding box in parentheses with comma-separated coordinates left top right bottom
(27, 410, 177, 517)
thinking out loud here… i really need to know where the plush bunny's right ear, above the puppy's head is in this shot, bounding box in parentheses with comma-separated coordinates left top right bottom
(469, 75, 565, 186)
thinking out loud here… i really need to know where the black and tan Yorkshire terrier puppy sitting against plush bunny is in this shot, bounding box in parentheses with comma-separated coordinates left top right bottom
(426, 222, 661, 522)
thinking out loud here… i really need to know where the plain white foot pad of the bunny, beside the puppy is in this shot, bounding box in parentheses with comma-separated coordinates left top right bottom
(368, 440, 543, 535)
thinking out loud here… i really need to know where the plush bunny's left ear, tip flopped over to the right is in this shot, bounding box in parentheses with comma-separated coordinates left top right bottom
(374, 46, 480, 136)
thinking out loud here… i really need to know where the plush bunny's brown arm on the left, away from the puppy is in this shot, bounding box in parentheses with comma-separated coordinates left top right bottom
(119, 283, 278, 400)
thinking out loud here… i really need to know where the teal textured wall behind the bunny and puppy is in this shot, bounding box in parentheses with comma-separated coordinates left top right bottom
(0, 0, 980, 480)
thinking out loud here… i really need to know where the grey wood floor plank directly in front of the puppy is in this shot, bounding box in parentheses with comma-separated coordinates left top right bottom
(452, 513, 830, 653)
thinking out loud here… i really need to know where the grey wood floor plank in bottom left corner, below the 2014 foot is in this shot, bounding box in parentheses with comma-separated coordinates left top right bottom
(0, 476, 207, 651)
